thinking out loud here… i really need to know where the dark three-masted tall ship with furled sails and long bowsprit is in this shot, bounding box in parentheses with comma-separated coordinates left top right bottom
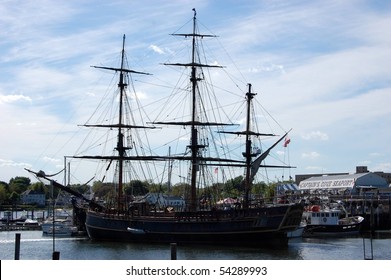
(28, 10, 303, 246)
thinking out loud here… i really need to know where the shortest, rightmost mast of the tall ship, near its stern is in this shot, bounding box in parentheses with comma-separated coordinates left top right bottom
(244, 84, 256, 207)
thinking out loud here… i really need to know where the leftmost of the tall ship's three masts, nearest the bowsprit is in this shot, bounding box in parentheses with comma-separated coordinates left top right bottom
(116, 35, 127, 209)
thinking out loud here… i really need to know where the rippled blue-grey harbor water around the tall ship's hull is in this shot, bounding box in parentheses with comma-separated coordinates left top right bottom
(0, 231, 391, 260)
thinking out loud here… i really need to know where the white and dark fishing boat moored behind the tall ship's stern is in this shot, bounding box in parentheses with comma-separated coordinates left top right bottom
(303, 205, 364, 237)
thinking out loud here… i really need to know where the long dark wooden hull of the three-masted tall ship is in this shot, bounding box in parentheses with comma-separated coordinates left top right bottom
(86, 205, 303, 246)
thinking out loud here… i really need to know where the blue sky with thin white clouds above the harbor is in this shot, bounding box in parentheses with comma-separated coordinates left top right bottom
(0, 0, 391, 186)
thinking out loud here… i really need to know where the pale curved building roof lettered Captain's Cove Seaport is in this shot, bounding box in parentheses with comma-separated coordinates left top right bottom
(299, 172, 388, 190)
